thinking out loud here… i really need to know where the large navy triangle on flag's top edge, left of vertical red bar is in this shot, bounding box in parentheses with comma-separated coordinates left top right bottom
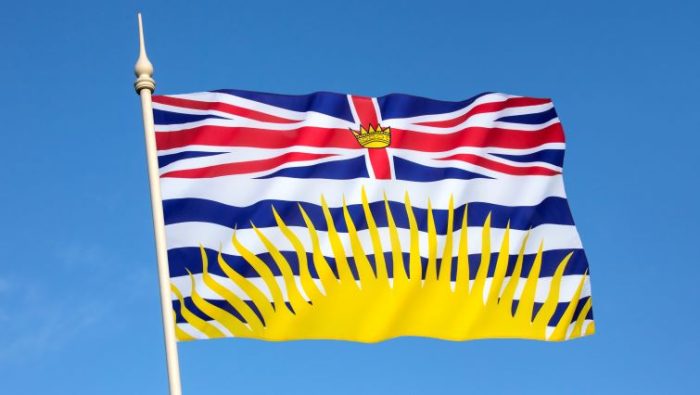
(214, 89, 354, 122)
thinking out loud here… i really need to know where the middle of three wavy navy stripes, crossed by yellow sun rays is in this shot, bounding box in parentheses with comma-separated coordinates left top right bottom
(168, 246, 588, 281)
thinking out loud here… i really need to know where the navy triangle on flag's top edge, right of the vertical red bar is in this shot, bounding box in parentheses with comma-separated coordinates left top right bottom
(377, 92, 488, 119)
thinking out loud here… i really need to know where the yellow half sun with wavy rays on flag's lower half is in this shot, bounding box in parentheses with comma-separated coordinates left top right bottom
(171, 189, 595, 342)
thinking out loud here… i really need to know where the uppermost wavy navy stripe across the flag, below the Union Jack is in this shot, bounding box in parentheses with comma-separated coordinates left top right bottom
(163, 197, 574, 234)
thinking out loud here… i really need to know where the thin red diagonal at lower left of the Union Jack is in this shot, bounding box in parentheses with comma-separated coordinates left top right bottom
(161, 152, 335, 178)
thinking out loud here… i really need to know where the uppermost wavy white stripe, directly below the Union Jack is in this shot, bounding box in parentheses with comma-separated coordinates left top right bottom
(160, 175, 566, 208)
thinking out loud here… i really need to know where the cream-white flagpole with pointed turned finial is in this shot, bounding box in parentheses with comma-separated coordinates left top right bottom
(134, 13, 182, 395)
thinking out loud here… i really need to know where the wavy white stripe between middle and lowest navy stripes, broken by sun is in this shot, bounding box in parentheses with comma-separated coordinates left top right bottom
(170, 273, 591, 303)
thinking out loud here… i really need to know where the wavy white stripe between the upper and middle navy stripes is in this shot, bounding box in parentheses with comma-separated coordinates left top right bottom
(165, 219, 582, 257)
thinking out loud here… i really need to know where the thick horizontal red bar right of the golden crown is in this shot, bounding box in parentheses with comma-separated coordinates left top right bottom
(391, 123, 564, 152)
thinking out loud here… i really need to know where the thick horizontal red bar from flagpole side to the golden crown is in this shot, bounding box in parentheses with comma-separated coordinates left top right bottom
(156, 125, 362, 150)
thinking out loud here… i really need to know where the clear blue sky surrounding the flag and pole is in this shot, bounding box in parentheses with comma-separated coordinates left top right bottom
(0, 0, 700, 395)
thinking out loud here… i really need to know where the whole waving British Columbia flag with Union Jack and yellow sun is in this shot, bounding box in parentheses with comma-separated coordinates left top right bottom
(153, 90, 595, 342)
